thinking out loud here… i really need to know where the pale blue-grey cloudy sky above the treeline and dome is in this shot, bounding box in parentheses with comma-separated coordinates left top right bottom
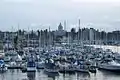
(0, 0, 120, 31)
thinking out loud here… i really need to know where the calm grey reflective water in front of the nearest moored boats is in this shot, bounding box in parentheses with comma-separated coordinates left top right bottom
(0, 70, 120, 80)
